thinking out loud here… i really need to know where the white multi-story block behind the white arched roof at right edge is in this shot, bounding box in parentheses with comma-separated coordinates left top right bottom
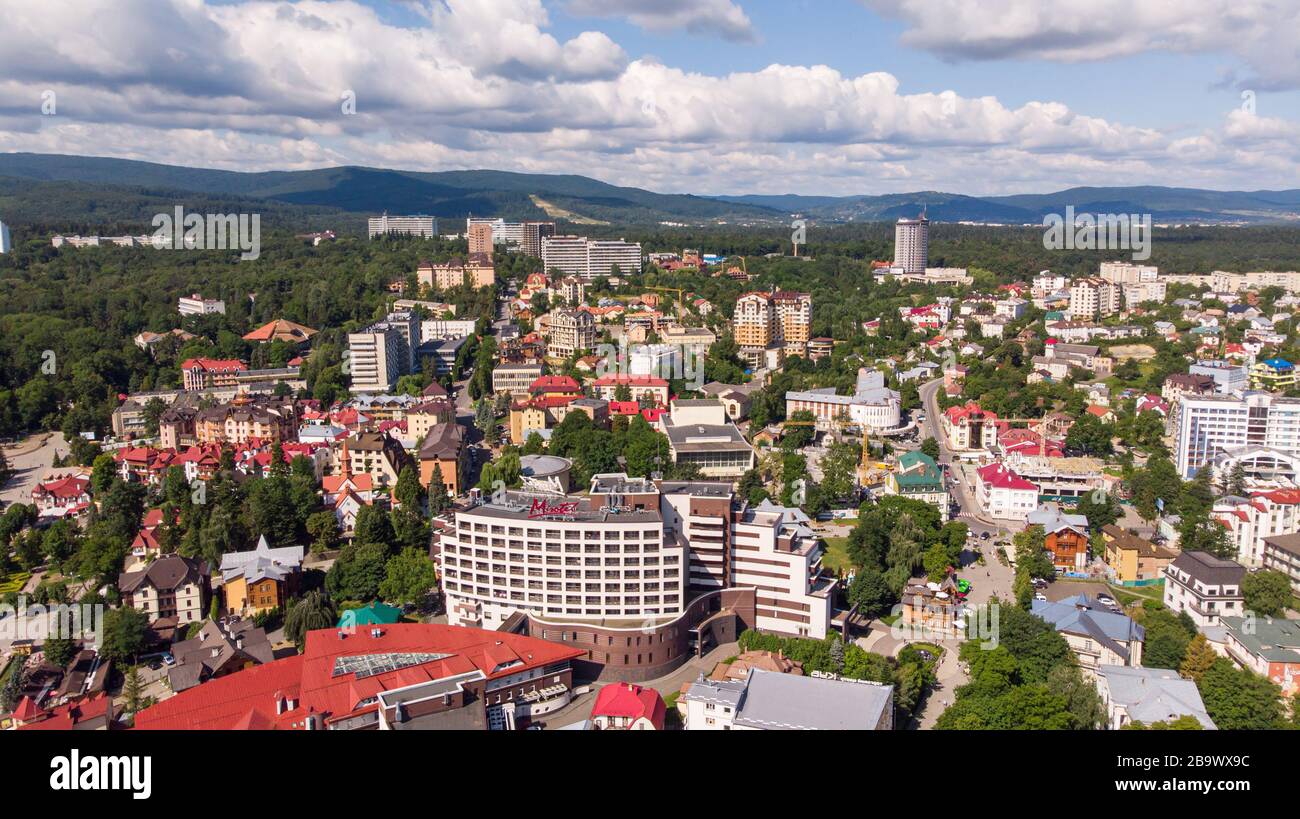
(1174, 391, 1300, 478)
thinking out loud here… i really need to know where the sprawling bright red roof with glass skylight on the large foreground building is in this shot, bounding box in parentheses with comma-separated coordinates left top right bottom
(135, 623, 584, 729)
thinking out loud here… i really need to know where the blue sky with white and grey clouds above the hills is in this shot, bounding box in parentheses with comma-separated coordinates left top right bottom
(0, 0, 1300, 195)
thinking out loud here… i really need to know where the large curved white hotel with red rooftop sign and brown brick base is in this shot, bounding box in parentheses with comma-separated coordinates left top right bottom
(433, 475, 836, 680)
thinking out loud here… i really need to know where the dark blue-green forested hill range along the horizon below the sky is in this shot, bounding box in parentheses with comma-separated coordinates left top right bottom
(0, 153, 1300, 225)
